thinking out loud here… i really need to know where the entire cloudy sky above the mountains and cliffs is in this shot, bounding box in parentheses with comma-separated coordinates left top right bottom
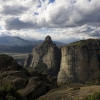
(0, 0, 100, 43)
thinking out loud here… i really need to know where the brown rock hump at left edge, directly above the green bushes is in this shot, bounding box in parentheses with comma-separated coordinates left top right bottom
(0, 71, 29, 90)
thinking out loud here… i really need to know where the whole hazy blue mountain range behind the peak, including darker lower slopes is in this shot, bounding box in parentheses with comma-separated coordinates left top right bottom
(0, 36, 64, 53)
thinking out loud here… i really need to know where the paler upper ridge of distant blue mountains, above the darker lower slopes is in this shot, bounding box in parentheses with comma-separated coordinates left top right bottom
(0, 36, 64, 46)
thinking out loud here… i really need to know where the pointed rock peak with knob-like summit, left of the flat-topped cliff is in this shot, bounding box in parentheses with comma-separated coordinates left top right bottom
(25, 36, 61, 75)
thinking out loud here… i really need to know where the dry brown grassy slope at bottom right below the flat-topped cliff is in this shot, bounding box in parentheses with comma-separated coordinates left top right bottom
(37, 84, 100, 100)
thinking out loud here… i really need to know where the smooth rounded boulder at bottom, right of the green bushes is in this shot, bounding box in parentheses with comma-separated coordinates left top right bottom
(18, 77, 46, 100)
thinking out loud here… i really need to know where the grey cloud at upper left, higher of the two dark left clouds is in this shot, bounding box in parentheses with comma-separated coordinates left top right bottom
(1, 5, 28, 15)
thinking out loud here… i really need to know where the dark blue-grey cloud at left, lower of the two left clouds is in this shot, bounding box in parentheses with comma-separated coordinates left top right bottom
(5, 18, 34, 30)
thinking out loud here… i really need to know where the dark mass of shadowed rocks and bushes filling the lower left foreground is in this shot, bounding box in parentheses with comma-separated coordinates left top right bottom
(0, 54, 57, 100)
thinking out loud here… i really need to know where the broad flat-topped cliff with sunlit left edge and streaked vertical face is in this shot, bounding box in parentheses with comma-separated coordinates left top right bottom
(57, 39, 100, 84)
